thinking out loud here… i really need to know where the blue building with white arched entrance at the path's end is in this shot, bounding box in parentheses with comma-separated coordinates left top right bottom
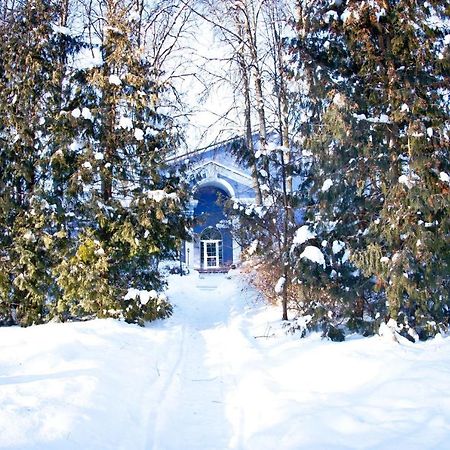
(177, 137, 255, 271)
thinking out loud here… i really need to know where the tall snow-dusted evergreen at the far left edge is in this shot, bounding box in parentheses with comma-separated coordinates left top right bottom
(0, 0, 80, 324)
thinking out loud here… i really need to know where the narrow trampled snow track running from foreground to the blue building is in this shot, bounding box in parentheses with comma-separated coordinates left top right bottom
(148, 276, 239, 449)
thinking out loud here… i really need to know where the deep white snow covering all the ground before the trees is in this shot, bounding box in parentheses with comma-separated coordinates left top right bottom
(0, 274, 450, 450)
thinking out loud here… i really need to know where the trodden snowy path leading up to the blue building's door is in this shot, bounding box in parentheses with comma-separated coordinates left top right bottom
(147, 275, 264, 450)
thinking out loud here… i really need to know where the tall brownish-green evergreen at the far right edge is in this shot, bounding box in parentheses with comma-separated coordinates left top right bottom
(344, 1, 450, 337)
